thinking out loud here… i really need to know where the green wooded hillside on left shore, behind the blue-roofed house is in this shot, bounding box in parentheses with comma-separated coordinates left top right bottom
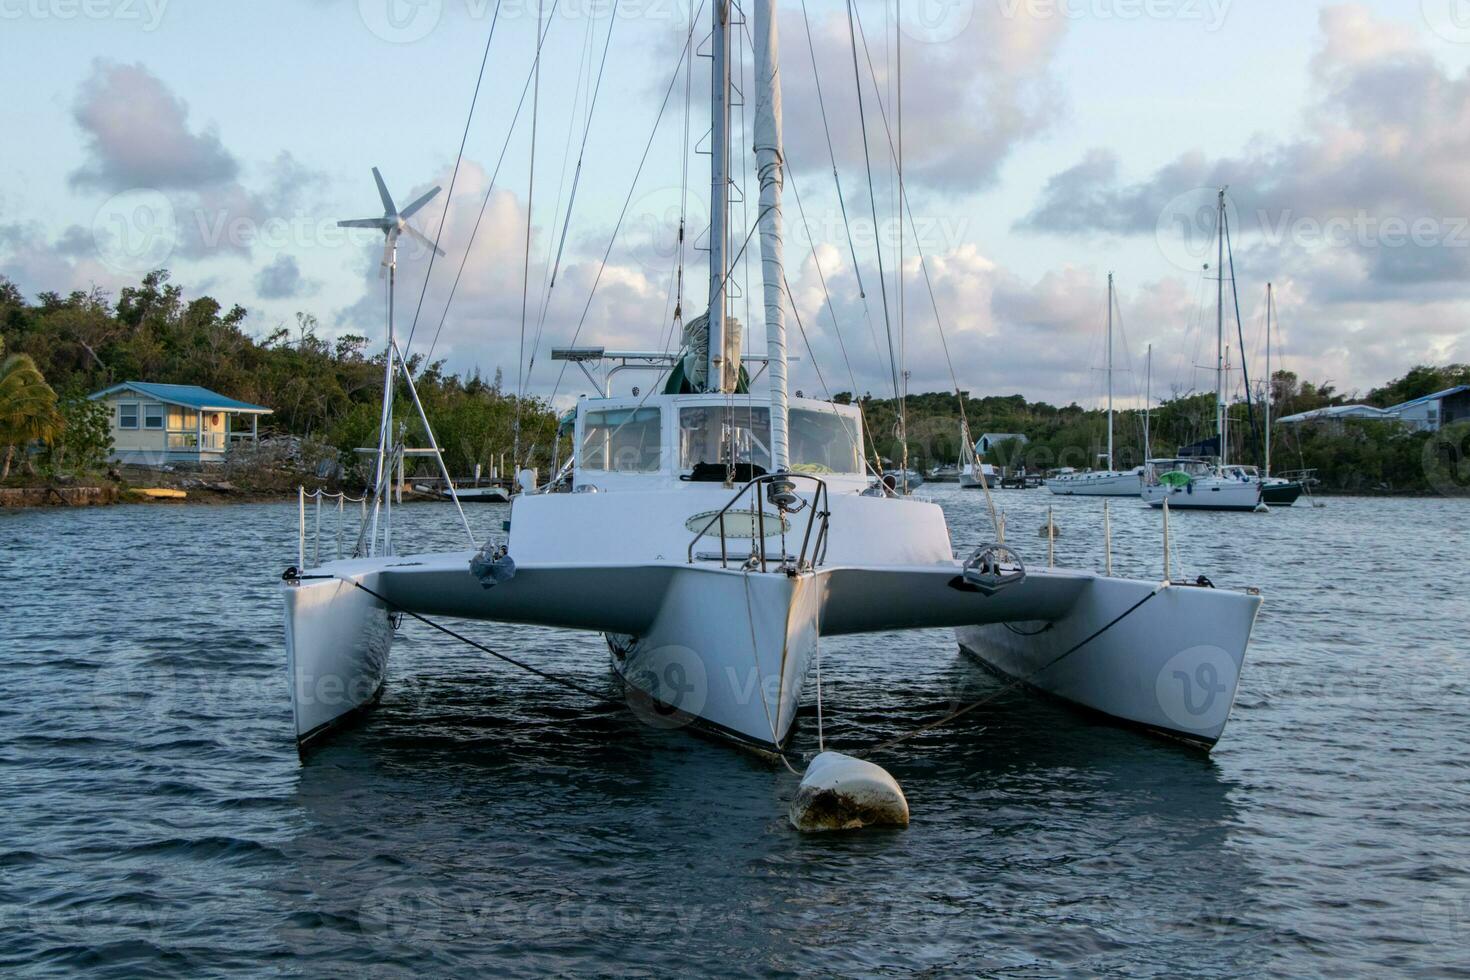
(0, 270, 556, 484)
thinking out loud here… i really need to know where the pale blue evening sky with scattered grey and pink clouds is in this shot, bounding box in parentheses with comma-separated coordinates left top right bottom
(0, 0, 1470, 404)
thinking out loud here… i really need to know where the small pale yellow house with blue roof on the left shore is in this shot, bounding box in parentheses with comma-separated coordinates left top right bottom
(90, 381, 270, 466)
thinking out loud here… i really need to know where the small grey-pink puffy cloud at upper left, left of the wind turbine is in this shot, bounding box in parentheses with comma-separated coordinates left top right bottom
(71, 60, 240, 192)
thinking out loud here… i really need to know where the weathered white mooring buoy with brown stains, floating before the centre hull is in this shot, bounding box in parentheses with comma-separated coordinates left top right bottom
(789, 752, 908, 833)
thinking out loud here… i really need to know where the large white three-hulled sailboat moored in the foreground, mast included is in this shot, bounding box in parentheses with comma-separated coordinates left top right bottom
(282, 0, 1261, 751)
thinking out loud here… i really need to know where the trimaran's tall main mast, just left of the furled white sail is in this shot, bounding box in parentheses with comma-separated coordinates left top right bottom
(707, 0, 739, 391)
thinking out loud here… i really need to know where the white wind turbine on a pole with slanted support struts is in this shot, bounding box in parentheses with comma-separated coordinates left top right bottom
(337, 167, 473, 554)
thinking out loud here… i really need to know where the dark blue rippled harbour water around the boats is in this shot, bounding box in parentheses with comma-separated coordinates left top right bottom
(0, 486, 1470, 977)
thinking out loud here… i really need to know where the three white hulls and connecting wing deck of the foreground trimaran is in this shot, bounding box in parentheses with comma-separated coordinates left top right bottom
(285, 531, 1260, 749)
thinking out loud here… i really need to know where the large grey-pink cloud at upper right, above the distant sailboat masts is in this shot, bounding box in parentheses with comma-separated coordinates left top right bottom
(1017, 4, 1470, 288)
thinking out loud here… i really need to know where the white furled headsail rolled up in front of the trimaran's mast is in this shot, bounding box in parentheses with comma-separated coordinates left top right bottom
(753, 0, 789, 473)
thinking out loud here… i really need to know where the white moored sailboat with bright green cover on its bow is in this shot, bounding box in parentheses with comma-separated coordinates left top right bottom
(1142, 188, 1266, 511)
